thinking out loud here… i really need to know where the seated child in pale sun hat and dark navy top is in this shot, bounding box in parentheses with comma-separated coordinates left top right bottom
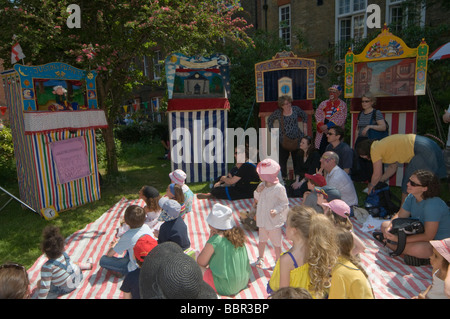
(155, 196, 191, 250)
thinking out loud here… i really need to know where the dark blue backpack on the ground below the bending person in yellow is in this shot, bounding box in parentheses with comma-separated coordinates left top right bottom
(364, 182, 400, 218)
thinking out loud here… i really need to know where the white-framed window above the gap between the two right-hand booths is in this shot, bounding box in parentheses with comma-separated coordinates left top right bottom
(335, 0, 367, 60)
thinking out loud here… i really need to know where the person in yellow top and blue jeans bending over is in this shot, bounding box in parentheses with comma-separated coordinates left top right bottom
(356, 134, 447, 203)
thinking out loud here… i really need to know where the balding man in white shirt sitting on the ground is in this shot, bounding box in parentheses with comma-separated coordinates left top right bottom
(320, 151, 358, 207)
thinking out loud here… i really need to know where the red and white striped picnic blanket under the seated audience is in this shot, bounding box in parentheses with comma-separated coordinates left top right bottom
(28, 198, 432, 299)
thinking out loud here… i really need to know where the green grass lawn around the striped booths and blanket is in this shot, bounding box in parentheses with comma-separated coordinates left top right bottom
(0, 141, 450, 268)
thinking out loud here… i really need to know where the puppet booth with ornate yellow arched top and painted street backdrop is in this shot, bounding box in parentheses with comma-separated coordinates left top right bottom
(345, 25, 428, 186)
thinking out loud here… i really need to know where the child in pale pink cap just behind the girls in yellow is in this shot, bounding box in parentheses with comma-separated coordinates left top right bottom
(321, 199, 366, 256)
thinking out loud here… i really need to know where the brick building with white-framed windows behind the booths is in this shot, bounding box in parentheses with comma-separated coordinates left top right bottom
(241, 0, 450, 79)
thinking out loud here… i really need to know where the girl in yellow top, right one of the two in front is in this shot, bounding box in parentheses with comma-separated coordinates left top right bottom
(328, 226, 374, 299)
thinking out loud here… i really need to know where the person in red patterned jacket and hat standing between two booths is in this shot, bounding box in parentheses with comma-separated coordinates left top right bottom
(314, 84, 347, 155)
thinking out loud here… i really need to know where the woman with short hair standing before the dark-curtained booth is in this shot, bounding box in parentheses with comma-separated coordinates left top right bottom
(267, 95, 308, 179)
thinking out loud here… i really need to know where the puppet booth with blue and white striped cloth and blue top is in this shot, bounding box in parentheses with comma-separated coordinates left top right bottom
(165, 53, 233, 183)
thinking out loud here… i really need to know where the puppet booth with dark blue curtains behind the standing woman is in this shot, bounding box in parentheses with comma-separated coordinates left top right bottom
(255, 51, 316, 179)
